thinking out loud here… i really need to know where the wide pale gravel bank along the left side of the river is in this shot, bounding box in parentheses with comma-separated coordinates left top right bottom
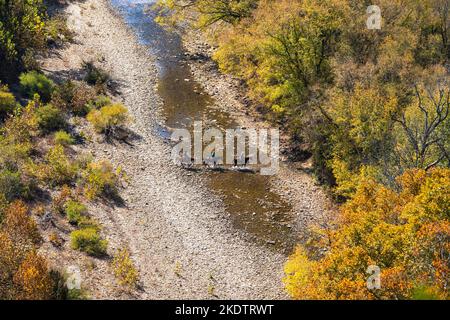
(38, 0, 294, 299)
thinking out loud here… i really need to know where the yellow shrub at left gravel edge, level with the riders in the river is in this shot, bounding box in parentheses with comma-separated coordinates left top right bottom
(83, 161, 122, 199)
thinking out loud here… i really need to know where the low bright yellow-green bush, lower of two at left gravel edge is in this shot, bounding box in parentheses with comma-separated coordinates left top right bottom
(70, 228, 108, 257)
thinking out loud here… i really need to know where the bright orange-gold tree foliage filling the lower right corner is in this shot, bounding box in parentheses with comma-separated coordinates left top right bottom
(284, 168, 450, 299)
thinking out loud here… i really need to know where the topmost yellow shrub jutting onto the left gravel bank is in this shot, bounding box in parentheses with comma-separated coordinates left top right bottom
(87, 104, 129, 135)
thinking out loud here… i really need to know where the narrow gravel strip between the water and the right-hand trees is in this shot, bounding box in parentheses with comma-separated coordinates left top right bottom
(183, 29, 335, 240)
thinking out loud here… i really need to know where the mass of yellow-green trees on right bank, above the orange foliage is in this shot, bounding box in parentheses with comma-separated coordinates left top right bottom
(157, 0, 450, 192)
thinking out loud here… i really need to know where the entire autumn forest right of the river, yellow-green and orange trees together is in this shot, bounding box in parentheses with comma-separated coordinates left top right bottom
(157, 0, 450, 299)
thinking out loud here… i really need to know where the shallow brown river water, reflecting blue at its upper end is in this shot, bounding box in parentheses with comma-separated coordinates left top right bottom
(111, 0, 296, 252)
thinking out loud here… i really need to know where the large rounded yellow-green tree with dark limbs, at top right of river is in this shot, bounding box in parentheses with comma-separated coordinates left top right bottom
(214, 0, 341, 122)
